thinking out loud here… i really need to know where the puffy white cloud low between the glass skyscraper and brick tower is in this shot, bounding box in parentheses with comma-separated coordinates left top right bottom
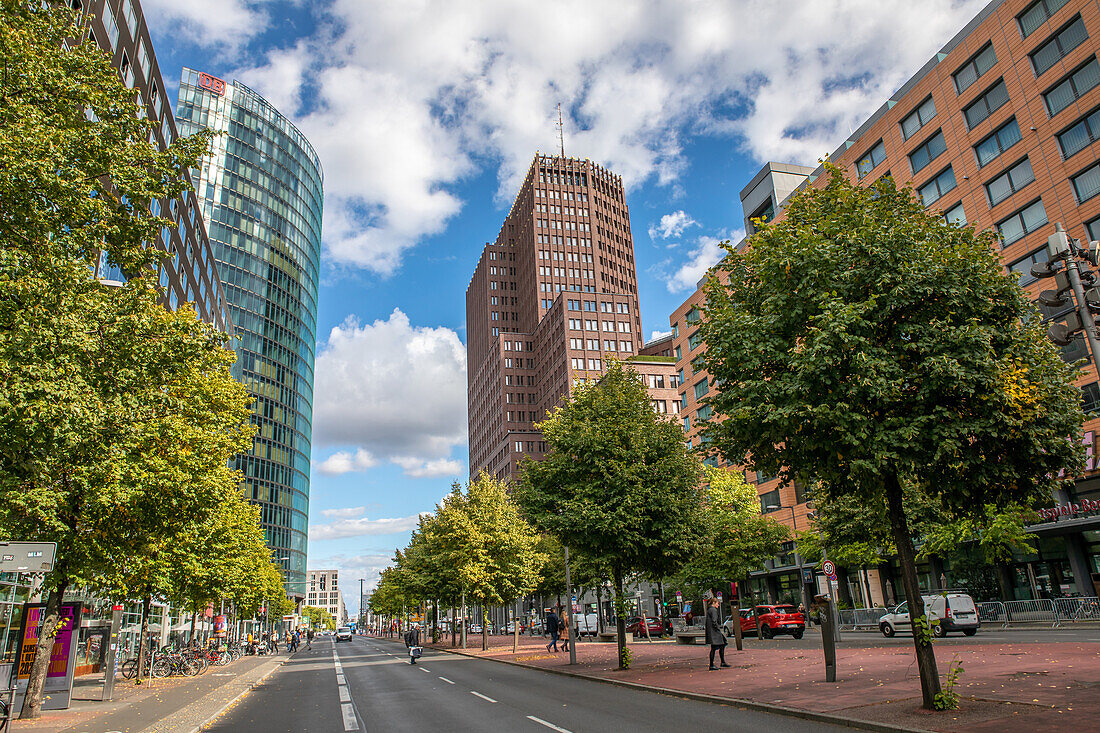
(314, 309, 466, 462)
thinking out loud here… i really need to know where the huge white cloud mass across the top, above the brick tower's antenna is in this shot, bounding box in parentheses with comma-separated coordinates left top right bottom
(234, 0, 986, 274)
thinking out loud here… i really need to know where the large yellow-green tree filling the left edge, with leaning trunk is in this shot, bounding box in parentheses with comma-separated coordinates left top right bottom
(0, 0, 242, 718)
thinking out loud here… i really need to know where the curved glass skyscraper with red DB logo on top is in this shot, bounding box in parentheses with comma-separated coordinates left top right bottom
(176, 68, 323, 599)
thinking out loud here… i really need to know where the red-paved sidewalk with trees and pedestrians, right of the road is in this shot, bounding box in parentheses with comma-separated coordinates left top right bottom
(415, 636, 1100, 733)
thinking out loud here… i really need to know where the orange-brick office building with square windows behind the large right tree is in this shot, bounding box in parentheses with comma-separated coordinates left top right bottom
(670, 0, 1100, 602)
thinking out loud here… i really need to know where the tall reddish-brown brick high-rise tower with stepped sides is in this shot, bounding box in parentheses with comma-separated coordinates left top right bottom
(466, 155, 642, 479)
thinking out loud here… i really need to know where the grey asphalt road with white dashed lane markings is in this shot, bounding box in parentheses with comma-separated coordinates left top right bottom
(209, 636, 849, 733)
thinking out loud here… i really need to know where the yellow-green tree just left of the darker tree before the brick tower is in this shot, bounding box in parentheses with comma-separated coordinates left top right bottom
(437, 472, 546, 649)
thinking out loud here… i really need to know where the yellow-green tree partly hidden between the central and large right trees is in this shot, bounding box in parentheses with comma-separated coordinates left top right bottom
(675, 466, 790, 589)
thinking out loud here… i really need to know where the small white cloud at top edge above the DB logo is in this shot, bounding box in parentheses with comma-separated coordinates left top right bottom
(137, 0, 267, 46)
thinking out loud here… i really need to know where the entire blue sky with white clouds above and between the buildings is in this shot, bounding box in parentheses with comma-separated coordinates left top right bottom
(142, 0, 985, 611)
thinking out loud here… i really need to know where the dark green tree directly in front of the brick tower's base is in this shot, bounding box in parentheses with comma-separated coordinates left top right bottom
(516, 361, 704, 668)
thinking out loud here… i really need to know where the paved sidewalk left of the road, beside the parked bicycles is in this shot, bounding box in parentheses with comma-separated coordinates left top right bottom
(11, 654, 290, 733)
